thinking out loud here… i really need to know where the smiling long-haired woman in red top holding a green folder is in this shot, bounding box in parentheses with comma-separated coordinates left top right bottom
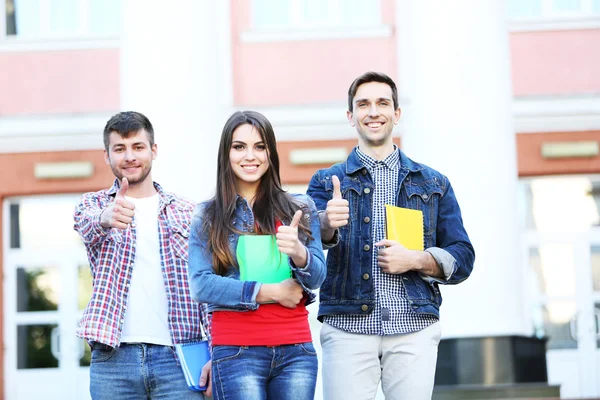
(189, 111, 325, 400)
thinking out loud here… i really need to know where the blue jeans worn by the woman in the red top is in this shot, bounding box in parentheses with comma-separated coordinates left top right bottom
(212, 343, 318, 400)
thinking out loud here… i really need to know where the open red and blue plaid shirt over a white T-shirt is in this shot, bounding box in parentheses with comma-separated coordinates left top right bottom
(74, 180, 211, 347)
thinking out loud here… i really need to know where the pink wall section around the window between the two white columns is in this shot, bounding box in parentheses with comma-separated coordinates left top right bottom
(232, 0, 397, 106)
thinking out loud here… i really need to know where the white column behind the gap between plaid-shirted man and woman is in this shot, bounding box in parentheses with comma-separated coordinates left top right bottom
(121, 0, 232, 201)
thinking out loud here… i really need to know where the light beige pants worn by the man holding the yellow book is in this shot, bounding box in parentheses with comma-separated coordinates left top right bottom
(321, 322, 441, 400)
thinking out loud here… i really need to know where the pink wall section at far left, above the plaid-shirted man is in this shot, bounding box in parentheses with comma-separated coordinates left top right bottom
(0, 49, 119, 116)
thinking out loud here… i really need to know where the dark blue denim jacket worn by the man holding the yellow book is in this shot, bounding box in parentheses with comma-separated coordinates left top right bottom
(307, 149, 475, 320)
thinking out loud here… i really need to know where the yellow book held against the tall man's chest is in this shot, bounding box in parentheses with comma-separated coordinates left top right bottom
(385, 204, 425, 250)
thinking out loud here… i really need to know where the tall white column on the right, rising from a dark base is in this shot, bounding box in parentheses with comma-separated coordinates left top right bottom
(396, 0, 531, 337)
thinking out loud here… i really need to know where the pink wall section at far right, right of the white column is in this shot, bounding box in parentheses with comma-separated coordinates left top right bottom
(510, 29, 600, 96)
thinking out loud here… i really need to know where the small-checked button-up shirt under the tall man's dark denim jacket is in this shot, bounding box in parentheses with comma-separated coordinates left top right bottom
(325, 145, 438, 335)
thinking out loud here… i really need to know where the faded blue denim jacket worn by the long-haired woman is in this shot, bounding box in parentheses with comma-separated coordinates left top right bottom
(188, 194, 325, 312)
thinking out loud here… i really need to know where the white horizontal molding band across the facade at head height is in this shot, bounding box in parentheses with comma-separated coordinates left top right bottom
(0, 94, 600, 153)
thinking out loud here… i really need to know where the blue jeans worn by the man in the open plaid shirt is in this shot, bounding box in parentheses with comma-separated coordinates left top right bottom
(90, 343, 204, 400)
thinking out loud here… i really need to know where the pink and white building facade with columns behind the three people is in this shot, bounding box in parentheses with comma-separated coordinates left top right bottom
(0, 0, 600, 399)
